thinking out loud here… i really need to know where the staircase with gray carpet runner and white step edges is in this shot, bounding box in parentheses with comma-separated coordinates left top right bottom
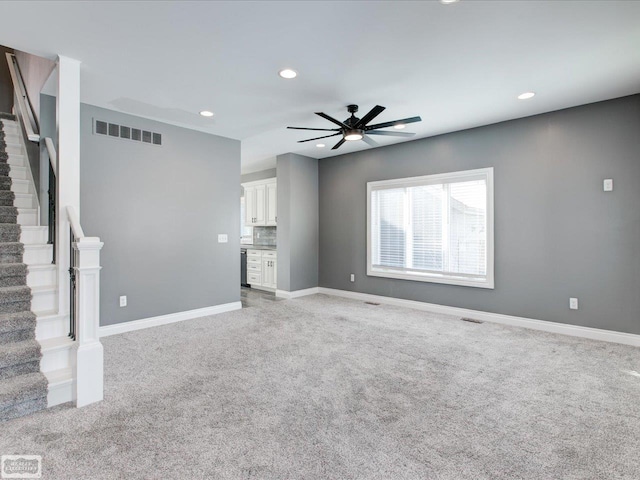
(0, 114, 74, 421)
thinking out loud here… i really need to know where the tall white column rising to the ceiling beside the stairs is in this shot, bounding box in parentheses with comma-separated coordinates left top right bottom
(56, 56, 80, 315)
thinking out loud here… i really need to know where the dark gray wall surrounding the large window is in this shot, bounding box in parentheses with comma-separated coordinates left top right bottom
(318, 95, 640, 334)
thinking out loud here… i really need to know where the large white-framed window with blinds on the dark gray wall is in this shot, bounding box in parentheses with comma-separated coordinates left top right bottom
(367, 168, 493, 288)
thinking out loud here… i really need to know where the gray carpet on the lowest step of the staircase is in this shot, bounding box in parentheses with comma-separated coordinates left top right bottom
(0, 372, 48, 421)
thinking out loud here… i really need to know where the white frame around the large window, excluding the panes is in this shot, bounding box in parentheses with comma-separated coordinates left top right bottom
(367, 167, 495, 289)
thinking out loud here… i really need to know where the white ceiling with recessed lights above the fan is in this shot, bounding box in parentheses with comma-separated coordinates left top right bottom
(0, 0, 640, 173)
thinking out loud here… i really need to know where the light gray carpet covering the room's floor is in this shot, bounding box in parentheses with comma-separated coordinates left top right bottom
(0, 295, 640, 480)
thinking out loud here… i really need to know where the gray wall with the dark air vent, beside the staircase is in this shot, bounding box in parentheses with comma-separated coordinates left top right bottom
(80, 104, 240, 325)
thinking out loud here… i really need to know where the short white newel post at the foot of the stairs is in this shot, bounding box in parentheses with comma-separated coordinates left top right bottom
(73, 237, 104, 407)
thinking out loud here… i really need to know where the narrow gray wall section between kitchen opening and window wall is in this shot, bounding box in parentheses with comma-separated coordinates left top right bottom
(276, 153, 319, 292)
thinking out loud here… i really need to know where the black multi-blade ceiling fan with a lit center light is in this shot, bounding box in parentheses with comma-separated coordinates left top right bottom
(287, 105, 422, 150)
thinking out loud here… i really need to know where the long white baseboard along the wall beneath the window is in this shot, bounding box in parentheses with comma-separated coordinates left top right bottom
(317, 287, 640, 347)
